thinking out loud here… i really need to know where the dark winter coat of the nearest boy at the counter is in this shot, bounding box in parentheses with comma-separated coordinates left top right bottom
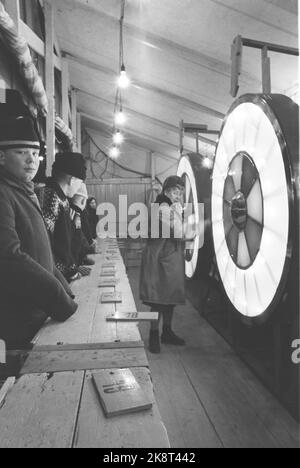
(0, 168, 77, 348)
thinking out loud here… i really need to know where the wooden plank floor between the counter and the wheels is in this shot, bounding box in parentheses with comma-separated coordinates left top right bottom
(128, 268, 300, 448)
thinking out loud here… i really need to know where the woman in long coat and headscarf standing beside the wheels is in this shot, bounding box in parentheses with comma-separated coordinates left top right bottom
(140, 176, 196, 353)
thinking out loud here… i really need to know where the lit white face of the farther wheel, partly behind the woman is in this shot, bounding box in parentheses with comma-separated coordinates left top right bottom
(177, 156, 200, 278)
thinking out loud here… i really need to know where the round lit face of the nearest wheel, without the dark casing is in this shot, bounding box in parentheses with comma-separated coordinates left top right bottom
(212, 103, 289, 318)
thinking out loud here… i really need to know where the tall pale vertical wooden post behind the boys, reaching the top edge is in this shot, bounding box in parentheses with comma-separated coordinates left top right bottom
(44, 0, 55, 176)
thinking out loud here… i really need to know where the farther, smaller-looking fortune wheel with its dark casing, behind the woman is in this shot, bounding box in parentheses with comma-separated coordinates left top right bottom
(177, 153, 213, 279)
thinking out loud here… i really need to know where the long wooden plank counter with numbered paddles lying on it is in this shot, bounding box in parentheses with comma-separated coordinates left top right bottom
(0, 240, 169, 448)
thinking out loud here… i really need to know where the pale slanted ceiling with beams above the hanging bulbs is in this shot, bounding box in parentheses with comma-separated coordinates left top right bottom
(55, 0, 298, 165)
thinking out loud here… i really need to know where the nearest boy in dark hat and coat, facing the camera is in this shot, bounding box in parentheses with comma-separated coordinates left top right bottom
(0, 117, 77, 349)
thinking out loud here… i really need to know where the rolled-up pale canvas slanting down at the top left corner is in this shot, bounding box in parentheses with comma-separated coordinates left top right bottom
(0, 1, 48, 116)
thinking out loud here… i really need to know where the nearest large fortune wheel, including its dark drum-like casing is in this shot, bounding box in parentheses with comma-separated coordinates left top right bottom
(212, 95, 299, 319)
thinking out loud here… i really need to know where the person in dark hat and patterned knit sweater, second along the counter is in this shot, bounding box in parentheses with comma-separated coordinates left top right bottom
(38, 152, 86, 282)
